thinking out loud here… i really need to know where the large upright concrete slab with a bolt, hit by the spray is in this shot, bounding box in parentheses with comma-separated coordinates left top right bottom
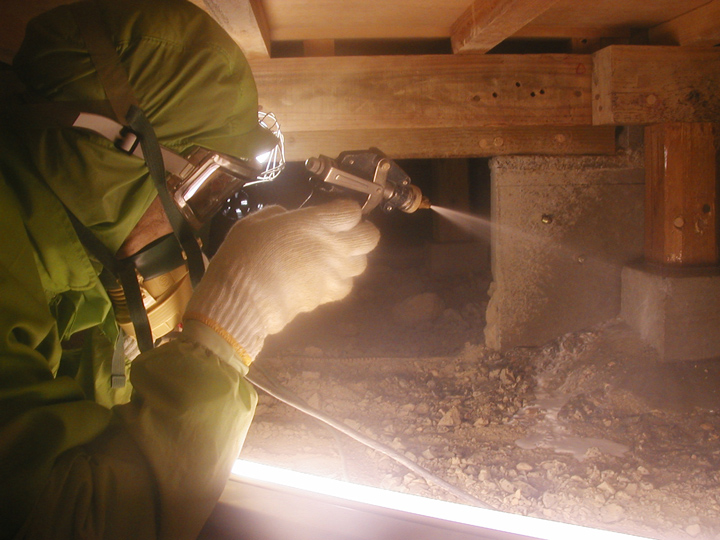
(485, 153, 644, 350)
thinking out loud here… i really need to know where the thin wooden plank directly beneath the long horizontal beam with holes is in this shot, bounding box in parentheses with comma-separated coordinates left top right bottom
(280, 126, 616, 161)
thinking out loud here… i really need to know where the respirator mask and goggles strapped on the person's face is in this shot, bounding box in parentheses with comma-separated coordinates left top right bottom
(73, 111, 285, 351)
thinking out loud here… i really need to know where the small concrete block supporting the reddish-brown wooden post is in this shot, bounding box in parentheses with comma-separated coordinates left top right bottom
(620, 263, 720, 362)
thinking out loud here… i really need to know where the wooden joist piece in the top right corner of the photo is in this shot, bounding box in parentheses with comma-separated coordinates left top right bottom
(650, 0, 720, 46)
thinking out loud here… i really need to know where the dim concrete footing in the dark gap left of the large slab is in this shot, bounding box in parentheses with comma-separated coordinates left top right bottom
(427, 242, 490, 276)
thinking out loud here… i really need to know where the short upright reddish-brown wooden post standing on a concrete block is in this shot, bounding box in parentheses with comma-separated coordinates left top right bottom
(645, 123, 718, 266)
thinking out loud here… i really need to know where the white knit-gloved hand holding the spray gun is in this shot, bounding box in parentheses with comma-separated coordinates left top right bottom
(184, 200, 380, 365)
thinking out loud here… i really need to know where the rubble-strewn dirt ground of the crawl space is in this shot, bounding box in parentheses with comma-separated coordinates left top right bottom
(241, 246, 720, 540)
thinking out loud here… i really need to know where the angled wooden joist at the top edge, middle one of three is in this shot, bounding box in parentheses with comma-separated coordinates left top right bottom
(450, 0, 557, 53)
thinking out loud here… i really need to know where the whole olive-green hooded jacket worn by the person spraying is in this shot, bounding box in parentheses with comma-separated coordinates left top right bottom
(0, 0, 276, 539)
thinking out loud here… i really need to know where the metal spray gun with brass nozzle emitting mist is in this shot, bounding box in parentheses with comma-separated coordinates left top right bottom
(305, 148, 430, 214)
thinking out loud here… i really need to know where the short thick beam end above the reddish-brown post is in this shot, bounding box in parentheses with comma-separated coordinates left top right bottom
(592, 45, 720, 125)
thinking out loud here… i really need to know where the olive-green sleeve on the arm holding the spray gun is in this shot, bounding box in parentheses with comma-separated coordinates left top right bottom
(16, 339, 256, 539)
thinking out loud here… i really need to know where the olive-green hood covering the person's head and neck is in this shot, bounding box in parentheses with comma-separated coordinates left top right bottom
(13, 0, 275, 254)
